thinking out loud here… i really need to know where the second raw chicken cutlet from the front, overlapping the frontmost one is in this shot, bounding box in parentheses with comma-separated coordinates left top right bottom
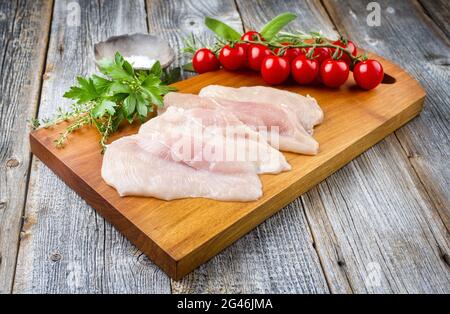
(139, 107, 291, 174)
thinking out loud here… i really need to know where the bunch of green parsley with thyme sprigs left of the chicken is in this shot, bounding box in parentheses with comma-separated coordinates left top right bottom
(32, 52, 174, 151)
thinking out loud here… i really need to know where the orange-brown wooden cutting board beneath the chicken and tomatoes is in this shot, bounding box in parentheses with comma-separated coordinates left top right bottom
(30, 57, 425, 280)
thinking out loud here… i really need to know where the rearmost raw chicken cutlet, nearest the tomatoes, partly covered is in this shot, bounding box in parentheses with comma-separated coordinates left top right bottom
(199, 85, 323, 134)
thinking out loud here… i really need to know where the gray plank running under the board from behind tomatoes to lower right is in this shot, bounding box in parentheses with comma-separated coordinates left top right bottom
(238, 1, 449, 293)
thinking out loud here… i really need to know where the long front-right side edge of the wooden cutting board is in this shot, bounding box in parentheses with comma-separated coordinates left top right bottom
(173, 95, 426, 281)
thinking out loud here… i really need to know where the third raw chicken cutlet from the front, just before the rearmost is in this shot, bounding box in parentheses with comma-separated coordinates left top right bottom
(159, 93, 319, 155)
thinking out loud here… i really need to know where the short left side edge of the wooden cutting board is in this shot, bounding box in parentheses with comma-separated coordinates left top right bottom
(30, 131, 177, 278)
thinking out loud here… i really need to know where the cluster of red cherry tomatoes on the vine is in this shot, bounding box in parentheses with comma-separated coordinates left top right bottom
(192, 31, 384, 90)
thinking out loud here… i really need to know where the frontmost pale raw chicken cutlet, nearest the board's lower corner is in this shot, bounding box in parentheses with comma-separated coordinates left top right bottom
(102, 135, 262, 202)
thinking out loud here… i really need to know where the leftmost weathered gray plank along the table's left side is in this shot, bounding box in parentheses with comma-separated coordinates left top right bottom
(0, 1, 52, 294)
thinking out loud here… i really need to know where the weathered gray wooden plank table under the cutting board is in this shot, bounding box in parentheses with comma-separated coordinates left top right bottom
(0, 0, 450, 293)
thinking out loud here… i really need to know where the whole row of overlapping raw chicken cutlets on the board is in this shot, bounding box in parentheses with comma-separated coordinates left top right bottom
(101, 86, 323, 202)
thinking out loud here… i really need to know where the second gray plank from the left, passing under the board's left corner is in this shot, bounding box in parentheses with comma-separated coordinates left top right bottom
(14, 0, 170, 293)
